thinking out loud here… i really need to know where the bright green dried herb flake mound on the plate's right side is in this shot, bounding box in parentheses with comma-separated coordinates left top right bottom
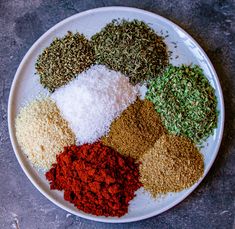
(146, 65, 218, 143)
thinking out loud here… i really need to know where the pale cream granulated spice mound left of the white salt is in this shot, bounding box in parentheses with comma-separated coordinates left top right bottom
(15, 98, 75, 170)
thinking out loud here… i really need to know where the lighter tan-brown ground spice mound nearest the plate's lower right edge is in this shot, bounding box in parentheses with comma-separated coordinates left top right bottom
(140, 135, 204, 197)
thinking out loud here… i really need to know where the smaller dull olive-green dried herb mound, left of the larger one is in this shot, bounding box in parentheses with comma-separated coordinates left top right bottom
(35, 32, 94, 92)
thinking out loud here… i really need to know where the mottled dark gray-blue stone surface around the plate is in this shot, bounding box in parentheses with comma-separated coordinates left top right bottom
(0, 0, 235, 229)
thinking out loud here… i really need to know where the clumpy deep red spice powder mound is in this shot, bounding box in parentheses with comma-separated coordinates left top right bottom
(46, 142, 142, 217)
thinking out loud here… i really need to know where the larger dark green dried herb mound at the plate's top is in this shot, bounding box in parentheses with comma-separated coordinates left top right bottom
(91, 20, 168, 85)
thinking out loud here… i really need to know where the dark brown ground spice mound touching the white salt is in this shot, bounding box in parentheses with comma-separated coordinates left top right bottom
(102, 99, 165, 159)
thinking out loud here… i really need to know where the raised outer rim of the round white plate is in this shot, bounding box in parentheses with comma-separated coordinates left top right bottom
(7, 6, 225, 223)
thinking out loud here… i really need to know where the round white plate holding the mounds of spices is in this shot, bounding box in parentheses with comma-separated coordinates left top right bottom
(8, 7, 224, 223)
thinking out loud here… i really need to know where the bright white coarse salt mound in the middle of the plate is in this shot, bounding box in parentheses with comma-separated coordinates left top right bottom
(51, 65, 139, 144)
